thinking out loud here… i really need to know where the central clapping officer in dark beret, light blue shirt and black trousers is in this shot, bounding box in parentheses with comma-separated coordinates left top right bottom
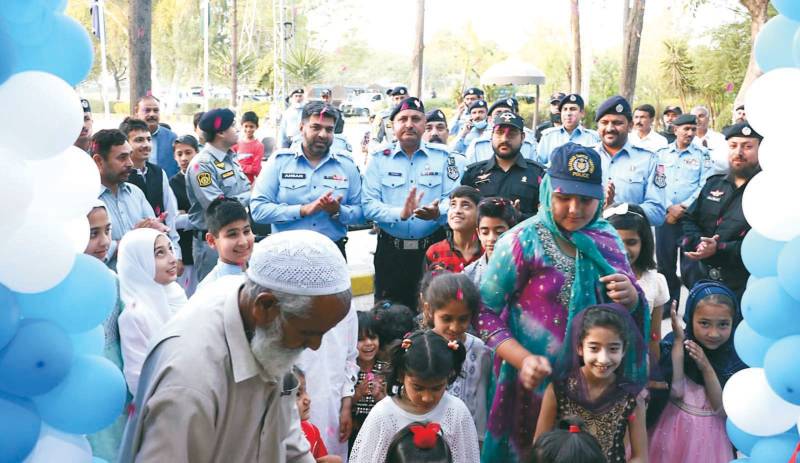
(362, 98, 461, 309)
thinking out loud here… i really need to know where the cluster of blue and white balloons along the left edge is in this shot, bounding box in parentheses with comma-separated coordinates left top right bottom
(0, 0, 126, 463)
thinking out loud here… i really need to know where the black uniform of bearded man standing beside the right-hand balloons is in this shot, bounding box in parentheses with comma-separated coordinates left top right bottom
(681, 174, 750, 290)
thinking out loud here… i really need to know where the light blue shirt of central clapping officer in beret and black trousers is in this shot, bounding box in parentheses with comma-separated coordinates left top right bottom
(362, 142, 462, 239)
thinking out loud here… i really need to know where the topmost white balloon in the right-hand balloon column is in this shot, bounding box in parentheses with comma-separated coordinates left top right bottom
(745, 68, 800, 137)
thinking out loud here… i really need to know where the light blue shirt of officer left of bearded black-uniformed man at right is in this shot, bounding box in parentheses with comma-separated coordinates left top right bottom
(657, 142, 714, 209)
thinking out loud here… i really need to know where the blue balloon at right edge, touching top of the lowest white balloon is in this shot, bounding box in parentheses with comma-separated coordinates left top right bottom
(764, 336, 800, 405)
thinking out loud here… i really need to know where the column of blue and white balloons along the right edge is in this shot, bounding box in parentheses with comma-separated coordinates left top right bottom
(722, 0, 800, 463)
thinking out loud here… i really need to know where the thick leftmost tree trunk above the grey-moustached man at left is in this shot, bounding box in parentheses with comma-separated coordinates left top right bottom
(128, 0, 153, 115)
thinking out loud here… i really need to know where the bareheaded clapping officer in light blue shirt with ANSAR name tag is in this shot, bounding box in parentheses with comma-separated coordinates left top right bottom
(250, 101, 364, 254)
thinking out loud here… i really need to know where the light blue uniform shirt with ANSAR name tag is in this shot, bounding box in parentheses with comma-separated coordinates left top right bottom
(250, 144, 364, 241)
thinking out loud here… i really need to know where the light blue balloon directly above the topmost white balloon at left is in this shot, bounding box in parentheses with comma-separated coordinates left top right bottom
(13, 13, 94, 85)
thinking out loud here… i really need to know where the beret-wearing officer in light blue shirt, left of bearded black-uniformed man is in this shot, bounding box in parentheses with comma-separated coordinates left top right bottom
(656, 114, 714, 301)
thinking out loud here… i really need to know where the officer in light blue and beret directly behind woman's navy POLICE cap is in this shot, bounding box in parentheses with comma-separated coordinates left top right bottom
(537, 93, 600, 165)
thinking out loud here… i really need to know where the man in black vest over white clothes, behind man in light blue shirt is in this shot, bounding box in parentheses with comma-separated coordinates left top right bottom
(119, 118, 183, 276)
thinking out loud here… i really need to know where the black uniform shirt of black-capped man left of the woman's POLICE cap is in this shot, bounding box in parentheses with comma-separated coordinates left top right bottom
(461, 150, 545, 219)
